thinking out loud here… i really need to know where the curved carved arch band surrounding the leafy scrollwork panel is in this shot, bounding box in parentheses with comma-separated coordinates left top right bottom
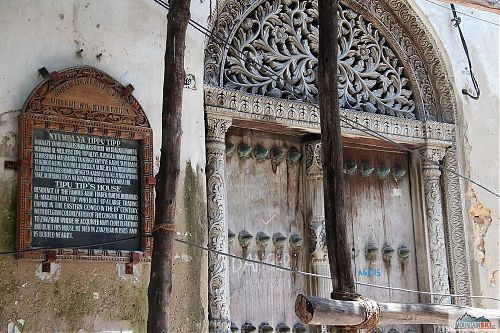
(205, 0, 457, 123)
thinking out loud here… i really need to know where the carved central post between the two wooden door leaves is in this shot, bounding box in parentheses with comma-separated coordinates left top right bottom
(305, 141, 332, 332)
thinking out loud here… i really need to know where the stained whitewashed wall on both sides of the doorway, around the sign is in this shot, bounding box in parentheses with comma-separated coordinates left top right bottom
(0, 0, 500, 332)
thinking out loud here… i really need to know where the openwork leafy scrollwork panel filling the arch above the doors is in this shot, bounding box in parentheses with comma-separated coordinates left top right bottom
(223, 0, 415, 119)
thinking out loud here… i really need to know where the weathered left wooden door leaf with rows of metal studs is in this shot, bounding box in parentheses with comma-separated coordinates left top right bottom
(225, 128, 306, 332)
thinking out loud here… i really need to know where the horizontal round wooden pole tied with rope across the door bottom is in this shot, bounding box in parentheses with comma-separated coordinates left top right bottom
(295, 295, 500, 331)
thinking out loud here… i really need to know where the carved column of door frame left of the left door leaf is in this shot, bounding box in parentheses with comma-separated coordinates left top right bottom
(206, 114, 231, 333)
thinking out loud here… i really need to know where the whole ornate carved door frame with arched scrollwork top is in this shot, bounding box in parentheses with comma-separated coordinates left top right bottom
(204, 0, 470, 332)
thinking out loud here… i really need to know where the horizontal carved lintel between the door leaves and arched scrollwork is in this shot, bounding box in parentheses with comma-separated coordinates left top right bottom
(205, 86, 455, 147)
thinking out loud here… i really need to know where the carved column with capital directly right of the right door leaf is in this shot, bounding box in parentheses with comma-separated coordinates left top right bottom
(420, 147, 451, 303)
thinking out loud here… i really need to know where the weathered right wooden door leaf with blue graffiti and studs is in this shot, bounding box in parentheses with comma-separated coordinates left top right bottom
(344, 143, 420, 333)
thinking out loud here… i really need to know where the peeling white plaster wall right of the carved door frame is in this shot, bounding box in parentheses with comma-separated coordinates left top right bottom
(412, 0, 500, 308)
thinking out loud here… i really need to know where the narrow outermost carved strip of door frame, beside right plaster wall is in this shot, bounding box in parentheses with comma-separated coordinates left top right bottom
(443, 146, 471, 306)
